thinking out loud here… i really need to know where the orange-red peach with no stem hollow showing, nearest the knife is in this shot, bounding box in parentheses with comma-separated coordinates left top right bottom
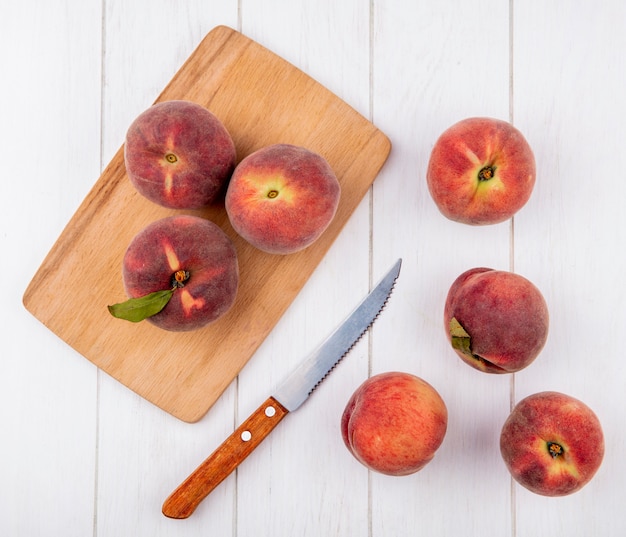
(341, 371, 448, 476)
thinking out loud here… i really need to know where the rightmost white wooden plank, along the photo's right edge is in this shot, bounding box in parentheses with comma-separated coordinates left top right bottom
(514, 1, 626, 537)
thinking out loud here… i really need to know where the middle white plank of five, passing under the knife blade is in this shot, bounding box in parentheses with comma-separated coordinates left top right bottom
(237, 0, 370, 537)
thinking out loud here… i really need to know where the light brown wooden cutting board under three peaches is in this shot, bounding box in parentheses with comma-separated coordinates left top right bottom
(23, 26, 391, 422)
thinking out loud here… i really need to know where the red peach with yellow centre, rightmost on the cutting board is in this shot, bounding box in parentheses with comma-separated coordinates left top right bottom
(226, 144, 341, 254)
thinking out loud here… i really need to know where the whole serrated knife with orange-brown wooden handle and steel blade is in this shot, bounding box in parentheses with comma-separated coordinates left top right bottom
(162, 259, 402, 518)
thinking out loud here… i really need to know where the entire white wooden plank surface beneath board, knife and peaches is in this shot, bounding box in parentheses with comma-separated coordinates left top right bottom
(0, 0, 626, 537)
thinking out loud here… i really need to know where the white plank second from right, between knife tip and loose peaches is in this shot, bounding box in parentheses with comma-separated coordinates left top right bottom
(370, 1, 511, 537)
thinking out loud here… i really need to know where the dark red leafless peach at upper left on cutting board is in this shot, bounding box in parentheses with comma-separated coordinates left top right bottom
(124, 100, 236, 209)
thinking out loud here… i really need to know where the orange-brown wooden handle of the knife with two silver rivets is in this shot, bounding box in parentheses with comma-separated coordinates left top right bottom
(162, 397, 289, 518)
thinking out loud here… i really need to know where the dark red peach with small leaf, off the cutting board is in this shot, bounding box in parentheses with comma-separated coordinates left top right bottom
(444, 267, 549, 373)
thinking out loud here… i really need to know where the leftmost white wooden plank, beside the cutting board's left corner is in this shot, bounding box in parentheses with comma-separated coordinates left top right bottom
(0, 0, 101, 537)
